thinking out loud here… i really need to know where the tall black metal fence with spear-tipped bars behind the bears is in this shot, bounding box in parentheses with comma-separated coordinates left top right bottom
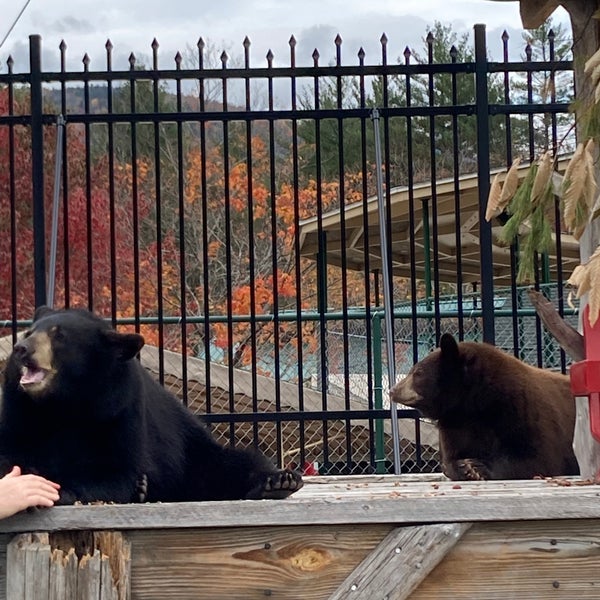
(0, 26, 577, 473)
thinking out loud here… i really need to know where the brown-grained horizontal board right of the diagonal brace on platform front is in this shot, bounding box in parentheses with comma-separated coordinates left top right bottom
(410, 520, 600, 600)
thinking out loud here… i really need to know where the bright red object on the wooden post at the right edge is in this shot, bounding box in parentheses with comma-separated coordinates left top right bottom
(570, 306, 600, 442)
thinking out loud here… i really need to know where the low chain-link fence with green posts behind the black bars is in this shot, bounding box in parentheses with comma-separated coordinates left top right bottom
(143, 285, 578, 474)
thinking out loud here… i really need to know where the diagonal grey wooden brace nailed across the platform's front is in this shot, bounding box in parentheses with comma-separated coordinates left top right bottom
(329, 523, 471, 600)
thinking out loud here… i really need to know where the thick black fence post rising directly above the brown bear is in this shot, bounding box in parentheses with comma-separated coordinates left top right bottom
(474, 24, 496, 344)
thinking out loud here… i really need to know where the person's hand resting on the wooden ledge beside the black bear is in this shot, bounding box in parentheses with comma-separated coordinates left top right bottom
(0, 467, 60, 519)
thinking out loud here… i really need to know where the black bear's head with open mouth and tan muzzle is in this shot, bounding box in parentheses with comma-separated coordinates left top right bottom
(6, 306, 144, 401)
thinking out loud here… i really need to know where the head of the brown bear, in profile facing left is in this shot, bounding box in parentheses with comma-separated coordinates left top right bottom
(390, 333, 468, 419)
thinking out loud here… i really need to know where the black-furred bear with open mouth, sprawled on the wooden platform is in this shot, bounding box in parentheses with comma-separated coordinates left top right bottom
(0, 307, 302, 504)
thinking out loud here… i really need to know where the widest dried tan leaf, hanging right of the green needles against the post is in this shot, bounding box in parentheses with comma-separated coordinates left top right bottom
(562, 139, 598, 240)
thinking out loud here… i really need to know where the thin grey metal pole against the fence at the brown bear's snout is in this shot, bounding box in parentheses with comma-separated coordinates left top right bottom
(372, 108, 400, 475)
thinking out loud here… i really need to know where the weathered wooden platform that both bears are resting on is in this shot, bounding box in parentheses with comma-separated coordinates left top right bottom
(0, 476, 600, 600)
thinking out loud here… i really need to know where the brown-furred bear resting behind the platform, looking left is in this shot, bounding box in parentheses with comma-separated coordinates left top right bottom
(390, 334, 579, 480)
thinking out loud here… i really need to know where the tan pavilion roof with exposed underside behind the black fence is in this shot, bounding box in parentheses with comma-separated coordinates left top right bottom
(299, 156, 580, 285)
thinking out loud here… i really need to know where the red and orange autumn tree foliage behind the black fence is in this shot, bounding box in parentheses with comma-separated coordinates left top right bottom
(0, 89, 372, 372)
